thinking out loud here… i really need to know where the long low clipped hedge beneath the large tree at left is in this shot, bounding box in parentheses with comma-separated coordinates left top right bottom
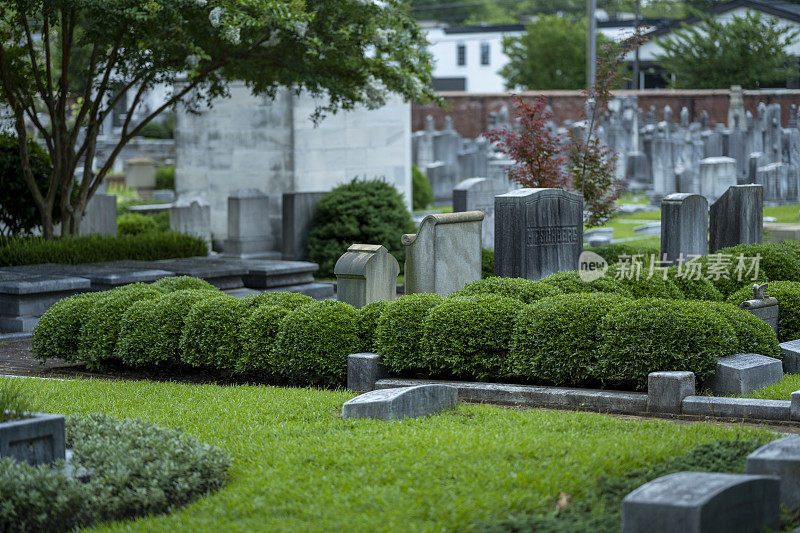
(0, 231, 208, 267)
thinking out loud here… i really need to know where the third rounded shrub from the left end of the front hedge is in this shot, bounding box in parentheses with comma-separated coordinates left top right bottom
(115, 300, 159, 367)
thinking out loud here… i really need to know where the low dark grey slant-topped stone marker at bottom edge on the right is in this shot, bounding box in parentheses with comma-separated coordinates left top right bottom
(622, 472, 780, 533)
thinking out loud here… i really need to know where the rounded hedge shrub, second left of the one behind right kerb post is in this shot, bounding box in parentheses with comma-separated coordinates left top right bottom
(423, 294, 525, 379)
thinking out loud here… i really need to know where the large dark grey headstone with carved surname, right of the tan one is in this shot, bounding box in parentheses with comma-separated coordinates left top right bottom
(494, 189, 583, 280)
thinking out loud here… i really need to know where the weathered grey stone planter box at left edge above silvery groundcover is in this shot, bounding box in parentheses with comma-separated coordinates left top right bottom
(0, 413, 66, 465)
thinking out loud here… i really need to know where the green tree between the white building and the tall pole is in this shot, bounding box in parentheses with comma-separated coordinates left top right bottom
(500, 15, 611, 90)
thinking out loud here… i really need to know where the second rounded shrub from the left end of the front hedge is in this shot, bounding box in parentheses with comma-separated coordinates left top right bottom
(78, 283, 164, 368)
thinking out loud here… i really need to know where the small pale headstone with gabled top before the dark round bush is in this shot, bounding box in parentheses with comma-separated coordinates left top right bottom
(333, 244, 400, 309)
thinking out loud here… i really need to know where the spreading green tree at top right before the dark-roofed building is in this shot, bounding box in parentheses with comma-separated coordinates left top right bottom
(658, 11, 800, 89)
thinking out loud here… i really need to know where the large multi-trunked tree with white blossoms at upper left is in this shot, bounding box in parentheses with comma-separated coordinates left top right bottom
(0, 0, 435, 238)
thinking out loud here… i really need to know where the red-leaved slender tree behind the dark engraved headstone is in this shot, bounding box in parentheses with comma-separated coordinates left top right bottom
(484, 28, 645, 227)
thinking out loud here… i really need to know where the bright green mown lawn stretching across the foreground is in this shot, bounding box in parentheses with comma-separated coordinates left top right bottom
(6, 378, 777, 532)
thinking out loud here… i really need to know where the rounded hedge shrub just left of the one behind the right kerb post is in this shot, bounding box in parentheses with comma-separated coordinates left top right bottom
(508, 293, 631, 385)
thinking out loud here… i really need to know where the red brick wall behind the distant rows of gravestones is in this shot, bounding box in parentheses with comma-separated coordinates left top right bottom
(411, 89, 800, 138)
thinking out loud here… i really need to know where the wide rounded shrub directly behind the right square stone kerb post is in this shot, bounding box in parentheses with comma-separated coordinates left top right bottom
(598, 298, 736, 389)
